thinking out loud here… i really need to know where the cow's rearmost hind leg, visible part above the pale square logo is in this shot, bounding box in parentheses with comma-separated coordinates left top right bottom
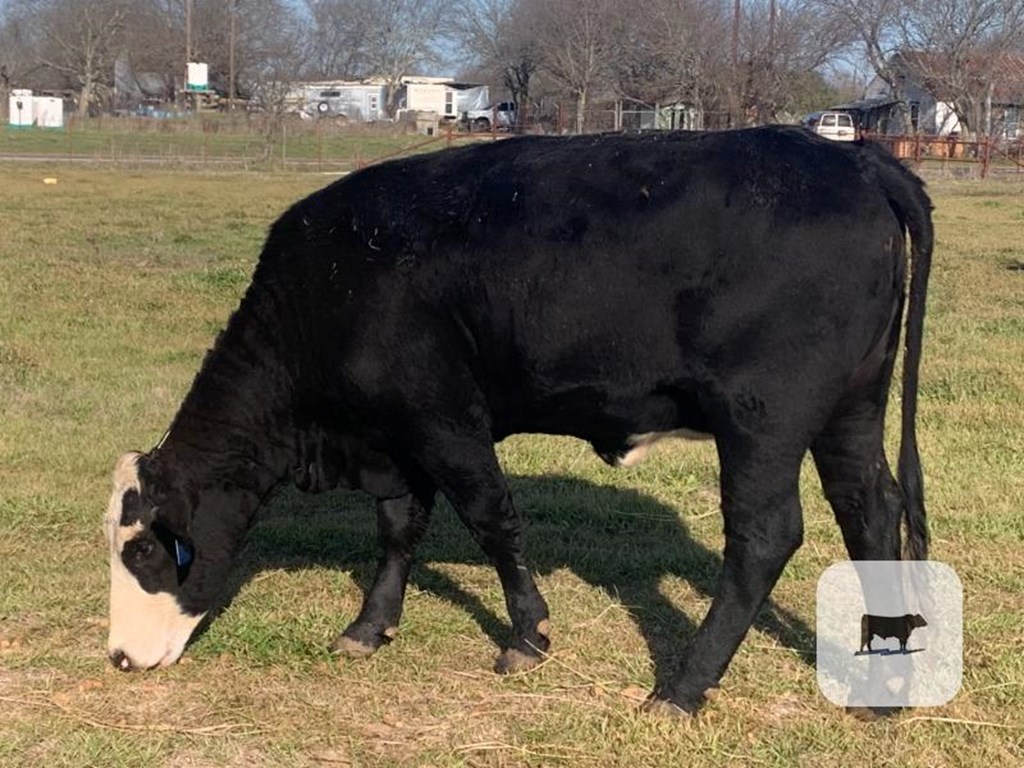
(811, 398, 903, 560)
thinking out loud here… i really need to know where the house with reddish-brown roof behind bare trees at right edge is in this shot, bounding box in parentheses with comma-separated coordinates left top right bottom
(865, 51, 1024, 138)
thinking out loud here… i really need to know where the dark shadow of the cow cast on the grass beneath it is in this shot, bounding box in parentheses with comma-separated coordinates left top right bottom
(224, 475, 815, 684)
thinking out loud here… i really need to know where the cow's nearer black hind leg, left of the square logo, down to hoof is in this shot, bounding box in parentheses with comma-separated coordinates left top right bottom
(647, 435, 803, 713)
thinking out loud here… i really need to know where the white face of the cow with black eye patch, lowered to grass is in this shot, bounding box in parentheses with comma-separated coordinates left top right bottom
(103, 453, 205, 671)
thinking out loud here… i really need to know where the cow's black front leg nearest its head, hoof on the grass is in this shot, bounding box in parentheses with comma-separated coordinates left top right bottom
(331, 492, 433, 657)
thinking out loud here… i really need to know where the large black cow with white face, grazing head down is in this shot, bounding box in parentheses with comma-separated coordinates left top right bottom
(106, 128, 932, 712)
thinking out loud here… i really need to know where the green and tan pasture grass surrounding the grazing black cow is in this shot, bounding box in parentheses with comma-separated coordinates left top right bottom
(0, 159, 1024, 768)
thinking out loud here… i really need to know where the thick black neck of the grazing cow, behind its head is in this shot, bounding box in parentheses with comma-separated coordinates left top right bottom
(155, 291, 295, 498)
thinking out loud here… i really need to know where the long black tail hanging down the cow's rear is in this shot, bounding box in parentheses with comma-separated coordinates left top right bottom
(881, 151, 934, 560)
